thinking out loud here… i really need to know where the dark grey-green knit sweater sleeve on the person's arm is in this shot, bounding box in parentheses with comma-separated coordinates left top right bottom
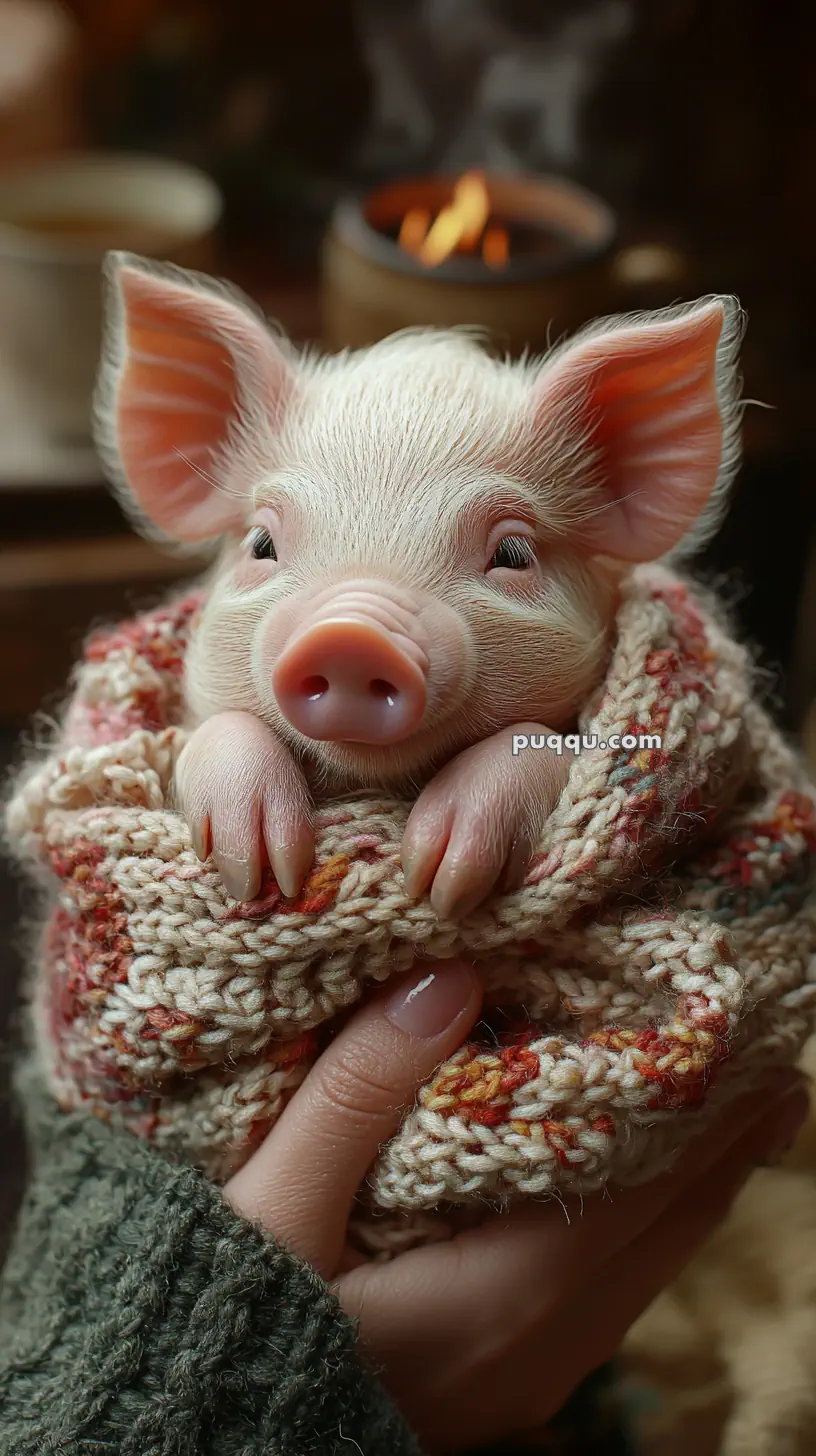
(0, 1069, 420, 1456)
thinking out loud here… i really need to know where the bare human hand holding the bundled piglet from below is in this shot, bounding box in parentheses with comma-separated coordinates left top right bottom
(224, 962, 809, 1453)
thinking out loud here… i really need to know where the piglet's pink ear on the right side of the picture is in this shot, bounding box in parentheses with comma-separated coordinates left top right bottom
(535, 298, 740, 562)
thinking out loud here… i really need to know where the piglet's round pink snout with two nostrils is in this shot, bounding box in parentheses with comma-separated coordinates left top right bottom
(272, 593, 428, 744)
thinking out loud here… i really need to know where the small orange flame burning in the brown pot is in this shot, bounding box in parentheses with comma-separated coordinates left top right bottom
(399, 172, 510, 268)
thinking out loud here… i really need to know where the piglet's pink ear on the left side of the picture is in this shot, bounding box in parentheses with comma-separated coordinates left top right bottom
(95, 253, 294, 542)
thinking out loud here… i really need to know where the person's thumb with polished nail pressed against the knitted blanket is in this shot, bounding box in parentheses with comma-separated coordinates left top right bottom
(224, 961, 482, 1278)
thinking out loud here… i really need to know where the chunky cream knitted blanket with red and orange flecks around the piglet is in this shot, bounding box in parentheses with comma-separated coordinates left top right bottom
(7, 566, 816, 1210)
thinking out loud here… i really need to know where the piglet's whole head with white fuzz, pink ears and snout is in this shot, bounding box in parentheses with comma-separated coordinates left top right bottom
(96, 253, 740, 786)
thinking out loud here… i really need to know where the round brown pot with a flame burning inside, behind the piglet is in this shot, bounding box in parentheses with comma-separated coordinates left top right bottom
(323, 170, 683, 354)
